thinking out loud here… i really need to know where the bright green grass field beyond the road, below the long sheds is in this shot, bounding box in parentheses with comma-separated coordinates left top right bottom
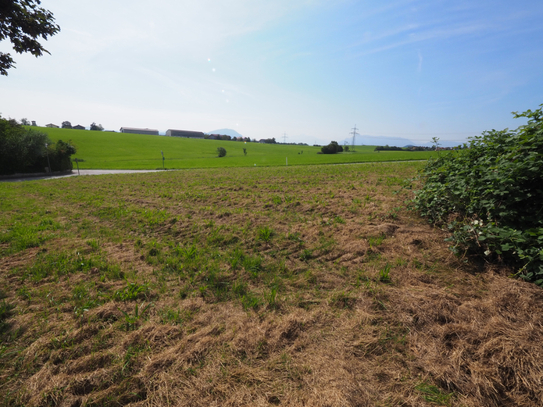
(39, 127, 438, 169)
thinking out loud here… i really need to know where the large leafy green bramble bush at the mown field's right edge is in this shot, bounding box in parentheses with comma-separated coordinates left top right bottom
(413, 104, 543, 286)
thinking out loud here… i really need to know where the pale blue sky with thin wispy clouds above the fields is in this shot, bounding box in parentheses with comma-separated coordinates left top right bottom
(0, 0, 543, 145)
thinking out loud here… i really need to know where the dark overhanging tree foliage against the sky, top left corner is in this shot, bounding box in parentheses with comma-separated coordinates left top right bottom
(0, 0, 60, 75)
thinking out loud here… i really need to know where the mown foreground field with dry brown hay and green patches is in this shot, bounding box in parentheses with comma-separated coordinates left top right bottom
(0, 163, 543, 407)
